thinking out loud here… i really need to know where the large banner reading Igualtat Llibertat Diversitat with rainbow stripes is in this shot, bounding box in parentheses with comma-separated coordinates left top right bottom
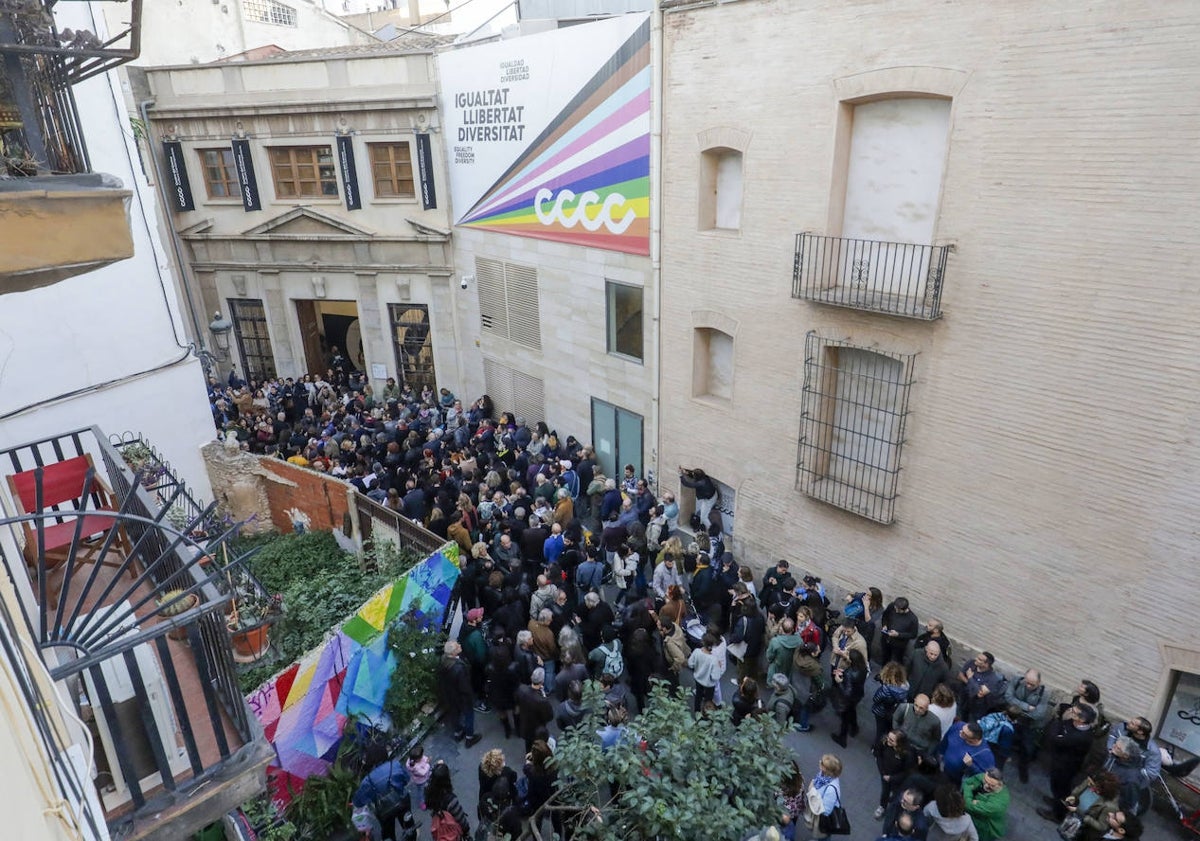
(439, 14, 650, 254)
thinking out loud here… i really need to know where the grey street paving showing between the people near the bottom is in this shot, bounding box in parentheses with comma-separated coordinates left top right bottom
(400, 678, 1180, 841)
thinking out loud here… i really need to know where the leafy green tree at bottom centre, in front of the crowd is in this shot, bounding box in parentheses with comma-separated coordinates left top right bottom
(554, 683, 791, 841)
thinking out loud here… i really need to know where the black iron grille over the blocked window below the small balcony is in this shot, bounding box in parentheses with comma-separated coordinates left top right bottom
(797, 332, 916, 523)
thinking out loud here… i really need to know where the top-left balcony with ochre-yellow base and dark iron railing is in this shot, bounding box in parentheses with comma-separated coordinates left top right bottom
(0, 0, 142, 294)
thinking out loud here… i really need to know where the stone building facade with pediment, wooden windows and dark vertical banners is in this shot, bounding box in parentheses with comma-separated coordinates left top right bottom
(148, 43, 462, 398)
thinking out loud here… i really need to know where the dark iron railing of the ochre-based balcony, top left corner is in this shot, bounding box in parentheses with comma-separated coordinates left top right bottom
(0, 0, 142, 176)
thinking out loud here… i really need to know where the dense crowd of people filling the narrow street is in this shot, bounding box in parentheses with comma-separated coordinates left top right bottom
(210, 366, 1180, 841)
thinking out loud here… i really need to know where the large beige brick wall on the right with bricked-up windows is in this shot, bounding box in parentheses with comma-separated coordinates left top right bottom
(661, 0, 1200, 713)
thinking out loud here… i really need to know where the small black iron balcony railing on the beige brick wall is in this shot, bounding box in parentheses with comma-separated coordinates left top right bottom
(792, 233, 953, 322)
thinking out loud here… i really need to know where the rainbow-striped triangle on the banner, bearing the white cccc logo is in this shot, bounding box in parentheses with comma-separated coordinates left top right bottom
(458, 19, 650, 254)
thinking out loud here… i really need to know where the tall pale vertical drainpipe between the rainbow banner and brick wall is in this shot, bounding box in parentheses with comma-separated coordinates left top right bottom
(650, 4, 665, 495)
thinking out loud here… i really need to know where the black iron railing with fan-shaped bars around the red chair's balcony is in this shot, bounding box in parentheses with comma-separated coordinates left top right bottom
(0, 427, 263, 821)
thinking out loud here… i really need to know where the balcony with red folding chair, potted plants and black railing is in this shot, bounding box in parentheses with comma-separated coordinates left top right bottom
(0, 427, 274, 841)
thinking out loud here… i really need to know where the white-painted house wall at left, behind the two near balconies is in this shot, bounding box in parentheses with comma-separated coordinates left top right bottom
(0, 4, 212, 495)
